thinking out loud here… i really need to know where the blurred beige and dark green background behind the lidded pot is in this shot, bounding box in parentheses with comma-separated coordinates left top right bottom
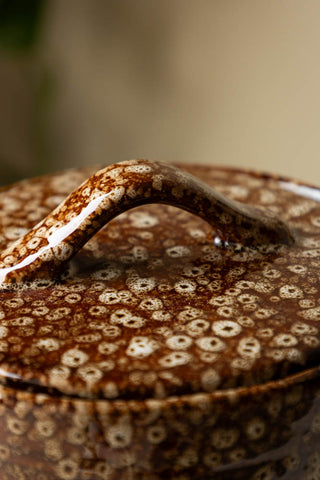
(0, 0, 320, 185)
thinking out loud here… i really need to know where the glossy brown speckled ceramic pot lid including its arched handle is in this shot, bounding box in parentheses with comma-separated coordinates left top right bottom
(0, 160, 320, 399)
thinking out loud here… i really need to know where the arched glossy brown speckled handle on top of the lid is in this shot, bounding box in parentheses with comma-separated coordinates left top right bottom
(0, 160, 293, 283)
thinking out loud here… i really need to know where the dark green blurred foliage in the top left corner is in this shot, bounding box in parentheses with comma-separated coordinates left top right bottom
(0, 0, 45, 52)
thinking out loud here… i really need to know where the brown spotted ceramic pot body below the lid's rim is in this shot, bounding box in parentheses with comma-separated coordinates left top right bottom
(0, 369, 320, 480)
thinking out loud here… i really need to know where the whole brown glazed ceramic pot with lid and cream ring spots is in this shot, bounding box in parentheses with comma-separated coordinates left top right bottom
(0, 160, 320, 480)
